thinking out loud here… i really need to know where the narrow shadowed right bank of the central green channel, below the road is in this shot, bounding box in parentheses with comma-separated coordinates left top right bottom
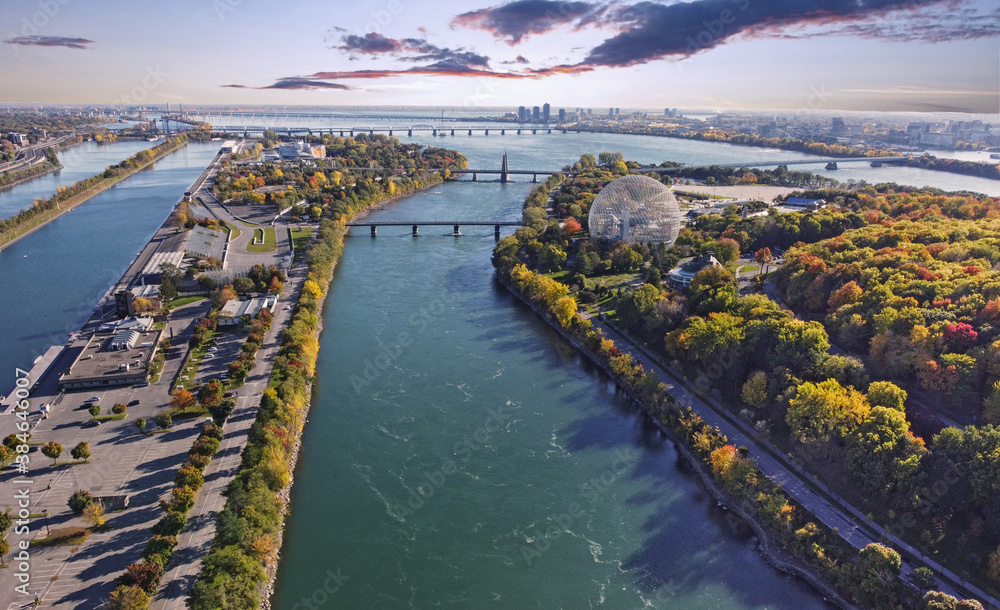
(497, 277, 859, 610)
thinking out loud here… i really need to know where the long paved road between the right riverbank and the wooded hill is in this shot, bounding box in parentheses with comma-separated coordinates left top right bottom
(588, 316, 1000, 608)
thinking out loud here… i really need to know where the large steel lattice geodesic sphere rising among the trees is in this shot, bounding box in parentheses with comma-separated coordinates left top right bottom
(587, 176, 681, 246)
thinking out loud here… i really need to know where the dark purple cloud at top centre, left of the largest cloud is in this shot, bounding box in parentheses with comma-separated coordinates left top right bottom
(451, 0, 605, 46)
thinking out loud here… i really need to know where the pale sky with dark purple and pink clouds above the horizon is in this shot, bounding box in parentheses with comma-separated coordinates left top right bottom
(0, 0, 1000, 114)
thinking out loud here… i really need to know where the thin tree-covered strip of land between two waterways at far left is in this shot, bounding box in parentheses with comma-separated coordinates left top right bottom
(0, 137, 188, 250)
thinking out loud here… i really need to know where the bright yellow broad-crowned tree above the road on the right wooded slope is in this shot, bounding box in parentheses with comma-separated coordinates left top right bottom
(785, 379, 871, 444)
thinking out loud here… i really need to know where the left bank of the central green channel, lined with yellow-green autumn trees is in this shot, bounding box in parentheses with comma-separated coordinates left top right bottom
(188, 172, 450, 609)
